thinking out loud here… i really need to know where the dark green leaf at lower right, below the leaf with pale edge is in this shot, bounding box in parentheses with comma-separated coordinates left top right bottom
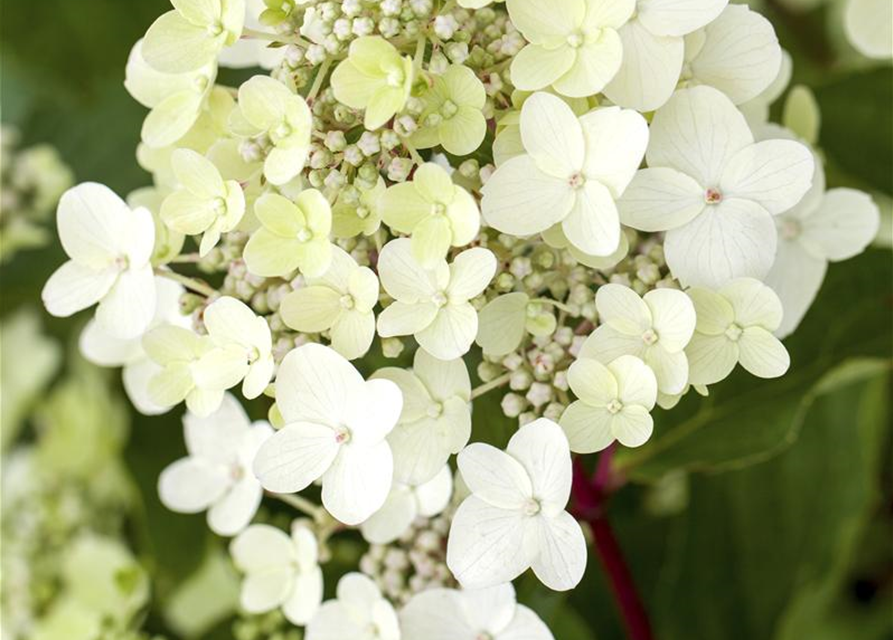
(652, 375, 889, 640)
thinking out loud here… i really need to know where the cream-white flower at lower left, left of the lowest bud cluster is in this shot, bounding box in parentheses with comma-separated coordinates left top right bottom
(229, 520, 323, 625)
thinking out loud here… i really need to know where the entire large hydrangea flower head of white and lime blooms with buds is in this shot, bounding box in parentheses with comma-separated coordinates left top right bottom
(43, 0, 878, 640)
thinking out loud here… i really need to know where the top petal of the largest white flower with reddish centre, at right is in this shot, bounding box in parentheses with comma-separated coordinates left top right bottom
(646, 87, 753, 189)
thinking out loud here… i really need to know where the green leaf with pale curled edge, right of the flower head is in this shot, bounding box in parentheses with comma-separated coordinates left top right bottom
(619, 251, 893, 481)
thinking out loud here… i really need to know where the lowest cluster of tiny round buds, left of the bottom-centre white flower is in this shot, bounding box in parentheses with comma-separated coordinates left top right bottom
(360, 512, 456, 604)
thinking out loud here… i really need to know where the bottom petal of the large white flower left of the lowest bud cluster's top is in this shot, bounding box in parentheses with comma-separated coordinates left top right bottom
(322, 440, 394, 525)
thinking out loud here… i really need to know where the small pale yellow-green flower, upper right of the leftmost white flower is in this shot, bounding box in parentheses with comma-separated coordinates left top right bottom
(160, 149, 245, 256)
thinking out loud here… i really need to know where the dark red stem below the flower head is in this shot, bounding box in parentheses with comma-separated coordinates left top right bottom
(572, 445, 654, 640)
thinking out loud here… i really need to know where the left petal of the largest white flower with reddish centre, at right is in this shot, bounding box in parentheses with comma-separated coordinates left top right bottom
(617, 167, 705, 231)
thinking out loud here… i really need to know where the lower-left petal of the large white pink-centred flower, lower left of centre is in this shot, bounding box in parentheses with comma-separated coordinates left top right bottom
(254, 422, 339, 493)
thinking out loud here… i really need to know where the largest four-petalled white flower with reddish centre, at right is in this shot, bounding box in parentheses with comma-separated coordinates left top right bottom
(618, 87, 815, 287)
